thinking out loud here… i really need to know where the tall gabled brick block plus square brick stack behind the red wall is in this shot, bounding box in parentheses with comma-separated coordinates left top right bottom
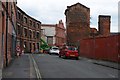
(65, 3, 111, 45)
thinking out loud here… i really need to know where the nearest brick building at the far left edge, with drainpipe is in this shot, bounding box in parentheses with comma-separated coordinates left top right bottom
(0, 0, 17, 68)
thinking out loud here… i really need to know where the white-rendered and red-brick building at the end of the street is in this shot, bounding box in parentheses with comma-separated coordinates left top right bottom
(41, 20, 66, 46)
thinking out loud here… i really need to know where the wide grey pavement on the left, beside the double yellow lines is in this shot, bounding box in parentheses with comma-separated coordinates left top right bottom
(2, 54, 34, 79)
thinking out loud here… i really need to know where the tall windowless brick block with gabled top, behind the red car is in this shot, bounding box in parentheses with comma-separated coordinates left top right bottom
(65, 3, 90, 45)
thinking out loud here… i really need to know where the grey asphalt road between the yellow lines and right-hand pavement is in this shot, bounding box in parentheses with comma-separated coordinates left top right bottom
(33, 54, 118, 78)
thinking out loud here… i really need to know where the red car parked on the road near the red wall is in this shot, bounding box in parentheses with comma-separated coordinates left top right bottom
(59, 46, 79, 60)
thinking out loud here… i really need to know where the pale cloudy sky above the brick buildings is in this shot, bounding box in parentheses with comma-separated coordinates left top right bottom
(17, 0, 119, 32)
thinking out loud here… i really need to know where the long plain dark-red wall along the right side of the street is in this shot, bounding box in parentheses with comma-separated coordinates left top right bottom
(80, 35, 120, 61)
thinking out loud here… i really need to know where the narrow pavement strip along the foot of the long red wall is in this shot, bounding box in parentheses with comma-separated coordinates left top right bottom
(82, 57, 120, 70)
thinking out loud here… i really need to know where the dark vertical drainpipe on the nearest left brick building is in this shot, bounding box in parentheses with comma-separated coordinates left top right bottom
(5, 0, 8, 67)
